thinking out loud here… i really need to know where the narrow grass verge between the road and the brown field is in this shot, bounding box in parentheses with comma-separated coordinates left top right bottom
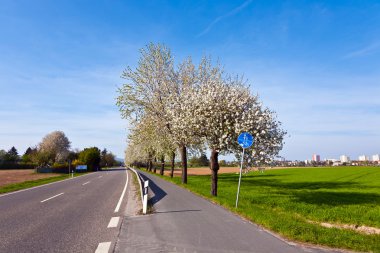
(0, 173, 87, 194)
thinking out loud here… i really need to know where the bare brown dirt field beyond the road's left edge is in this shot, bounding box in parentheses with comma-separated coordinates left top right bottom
(0, 170, 59, 187)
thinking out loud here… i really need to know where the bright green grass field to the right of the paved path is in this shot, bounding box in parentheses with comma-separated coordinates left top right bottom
(153, 167, 380, 252)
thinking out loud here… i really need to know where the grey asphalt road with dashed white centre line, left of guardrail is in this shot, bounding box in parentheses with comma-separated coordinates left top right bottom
(0, 169, 127, 253)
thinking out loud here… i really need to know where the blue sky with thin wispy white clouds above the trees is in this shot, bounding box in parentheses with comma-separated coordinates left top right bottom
(0, 0, 380, 160)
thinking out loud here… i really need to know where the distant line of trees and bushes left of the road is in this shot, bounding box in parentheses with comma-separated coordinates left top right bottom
(0, 131, 121, 172)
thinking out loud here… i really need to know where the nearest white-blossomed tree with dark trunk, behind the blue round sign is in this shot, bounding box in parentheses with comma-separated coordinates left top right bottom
(181, 59, 285, 196)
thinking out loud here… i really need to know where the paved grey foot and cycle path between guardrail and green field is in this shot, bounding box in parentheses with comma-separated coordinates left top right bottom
(115, 173, 339, 253)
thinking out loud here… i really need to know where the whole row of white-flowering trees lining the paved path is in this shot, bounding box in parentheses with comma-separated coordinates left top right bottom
(117, 44, 286, 196)
